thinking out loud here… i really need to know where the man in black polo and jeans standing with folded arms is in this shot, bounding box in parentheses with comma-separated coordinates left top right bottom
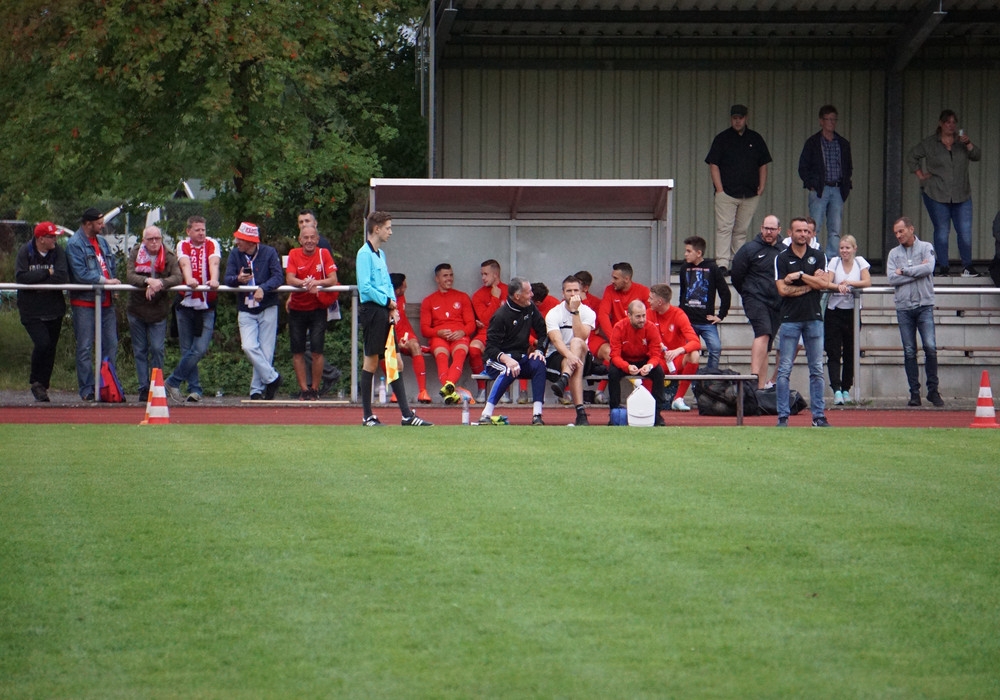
(774, 218, 830, 428)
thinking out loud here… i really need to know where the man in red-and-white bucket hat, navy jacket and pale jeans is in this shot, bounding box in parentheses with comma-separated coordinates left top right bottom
(224, 221, 285, 401)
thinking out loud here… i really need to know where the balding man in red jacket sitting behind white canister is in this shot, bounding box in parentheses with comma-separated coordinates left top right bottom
(608, 299, 667, 425)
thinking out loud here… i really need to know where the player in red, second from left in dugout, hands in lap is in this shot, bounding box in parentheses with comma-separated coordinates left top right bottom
(420, 263, 476, 403)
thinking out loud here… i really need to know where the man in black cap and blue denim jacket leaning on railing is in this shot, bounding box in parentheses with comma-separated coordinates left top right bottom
(66, 207, 121, 401)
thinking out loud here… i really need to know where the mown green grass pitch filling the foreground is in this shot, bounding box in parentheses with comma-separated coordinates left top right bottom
(0, 425, 1000, 698)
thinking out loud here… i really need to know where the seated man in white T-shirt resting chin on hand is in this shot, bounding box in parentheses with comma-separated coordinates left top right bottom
(545, 275, 597, 425)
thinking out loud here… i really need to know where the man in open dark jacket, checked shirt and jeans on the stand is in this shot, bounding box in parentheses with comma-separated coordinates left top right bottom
(799, 105, 854, 260)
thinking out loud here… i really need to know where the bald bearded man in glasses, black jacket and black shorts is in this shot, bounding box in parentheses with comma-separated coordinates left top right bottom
(732, 214, 785, 389)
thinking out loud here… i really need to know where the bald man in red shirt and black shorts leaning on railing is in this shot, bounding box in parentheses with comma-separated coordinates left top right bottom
(285, 225, 340, 401)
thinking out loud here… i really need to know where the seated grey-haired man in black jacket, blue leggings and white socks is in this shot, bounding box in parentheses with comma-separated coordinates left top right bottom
(479, 277, 552, 425)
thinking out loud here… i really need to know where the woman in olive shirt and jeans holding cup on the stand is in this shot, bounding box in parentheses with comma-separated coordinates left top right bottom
(907, 109, 982, 277)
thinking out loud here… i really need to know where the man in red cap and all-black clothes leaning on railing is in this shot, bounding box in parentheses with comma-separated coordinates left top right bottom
(14, 221, 69, 401)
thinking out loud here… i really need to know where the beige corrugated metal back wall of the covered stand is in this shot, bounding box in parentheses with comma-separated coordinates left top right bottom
(438, 50, 1000, 266)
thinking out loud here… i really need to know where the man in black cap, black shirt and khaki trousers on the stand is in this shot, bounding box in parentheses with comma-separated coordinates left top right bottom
(705, 105, 771, 274)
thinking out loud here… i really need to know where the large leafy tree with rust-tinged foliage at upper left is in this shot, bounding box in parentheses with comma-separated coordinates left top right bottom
(0, 0, 422, 235)
